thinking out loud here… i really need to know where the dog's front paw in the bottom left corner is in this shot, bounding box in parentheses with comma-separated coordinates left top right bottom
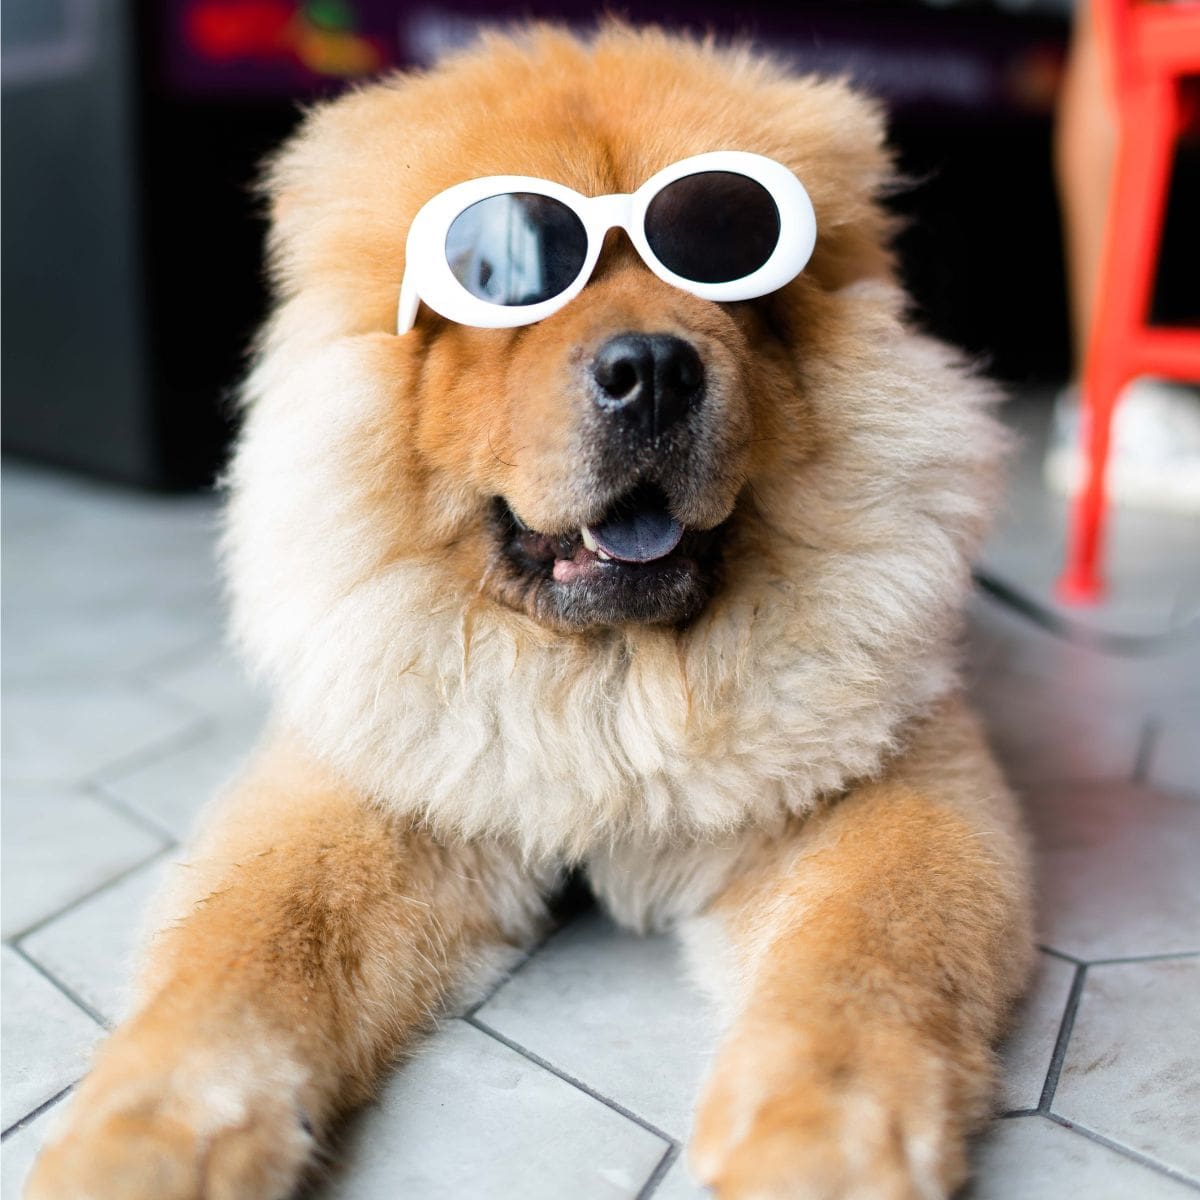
(25, 1027, 314, 1200)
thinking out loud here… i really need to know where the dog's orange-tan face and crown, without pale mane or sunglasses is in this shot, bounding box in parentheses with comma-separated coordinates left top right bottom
(248, 30, 888, 628)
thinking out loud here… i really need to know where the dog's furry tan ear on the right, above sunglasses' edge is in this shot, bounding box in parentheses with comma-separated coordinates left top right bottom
(772, 78, 898, 289)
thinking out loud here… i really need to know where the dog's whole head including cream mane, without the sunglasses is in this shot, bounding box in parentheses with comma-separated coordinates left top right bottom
(228, 26, 997, 845)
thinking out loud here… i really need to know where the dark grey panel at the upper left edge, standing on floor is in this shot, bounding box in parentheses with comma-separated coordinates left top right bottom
(0, 0, 154, 479)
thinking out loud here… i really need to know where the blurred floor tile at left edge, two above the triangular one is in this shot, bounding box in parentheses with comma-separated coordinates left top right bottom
(4, 679, 197, 784)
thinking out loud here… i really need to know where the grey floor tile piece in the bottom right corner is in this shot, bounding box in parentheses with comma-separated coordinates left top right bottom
(958, 1117, 1195, 1200)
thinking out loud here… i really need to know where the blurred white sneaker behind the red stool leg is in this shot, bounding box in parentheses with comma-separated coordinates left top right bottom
(1042, 378, 1200, 512)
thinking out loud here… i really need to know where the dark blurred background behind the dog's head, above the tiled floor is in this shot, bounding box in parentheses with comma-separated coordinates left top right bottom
(2, 0, 1200, 488)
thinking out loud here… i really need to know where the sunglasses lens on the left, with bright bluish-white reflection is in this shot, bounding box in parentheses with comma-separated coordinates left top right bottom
(446, 192, 588, 305)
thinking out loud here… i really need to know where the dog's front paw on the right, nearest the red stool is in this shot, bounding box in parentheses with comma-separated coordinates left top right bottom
(689, 1033, 990, 1200)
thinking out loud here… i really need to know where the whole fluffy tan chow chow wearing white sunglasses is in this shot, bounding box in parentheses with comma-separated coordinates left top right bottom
(29, 25, 1031, 1200)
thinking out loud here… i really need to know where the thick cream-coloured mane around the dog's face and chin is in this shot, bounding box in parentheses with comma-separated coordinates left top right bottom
(227, 284, 1003, 858)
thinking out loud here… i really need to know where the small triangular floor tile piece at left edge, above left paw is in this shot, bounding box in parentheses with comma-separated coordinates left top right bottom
(0, 946, 101, 1129)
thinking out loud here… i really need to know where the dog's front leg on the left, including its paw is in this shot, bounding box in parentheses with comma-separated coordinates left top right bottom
(26, 748, 541, 1200)
